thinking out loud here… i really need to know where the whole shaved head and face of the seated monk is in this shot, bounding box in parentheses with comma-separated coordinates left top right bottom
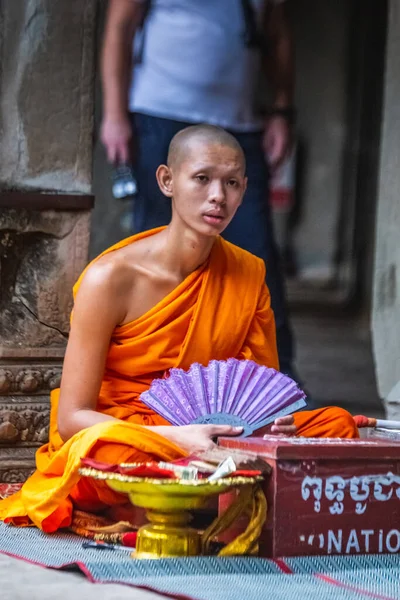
(156, 125, 247, 237)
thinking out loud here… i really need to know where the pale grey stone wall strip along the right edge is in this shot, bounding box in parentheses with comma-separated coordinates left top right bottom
(372, 0, 400, 419)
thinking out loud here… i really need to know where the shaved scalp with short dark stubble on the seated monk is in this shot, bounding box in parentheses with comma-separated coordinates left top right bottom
(168, 124, 246, 170)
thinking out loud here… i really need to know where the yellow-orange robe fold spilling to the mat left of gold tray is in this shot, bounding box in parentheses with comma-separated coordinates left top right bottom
(0, 421, 184, 532)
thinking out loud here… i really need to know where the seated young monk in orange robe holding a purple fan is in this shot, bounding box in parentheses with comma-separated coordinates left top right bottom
(0, 126, 358, 532)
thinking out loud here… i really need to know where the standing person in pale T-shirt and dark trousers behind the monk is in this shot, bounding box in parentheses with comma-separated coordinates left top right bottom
(101, 0, 304, 390)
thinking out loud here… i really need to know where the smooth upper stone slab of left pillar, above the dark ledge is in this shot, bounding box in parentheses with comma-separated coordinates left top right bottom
(0, 0, 96, 193)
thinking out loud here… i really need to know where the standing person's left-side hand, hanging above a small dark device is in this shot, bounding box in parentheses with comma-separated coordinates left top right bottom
(100, 115, 132, 165)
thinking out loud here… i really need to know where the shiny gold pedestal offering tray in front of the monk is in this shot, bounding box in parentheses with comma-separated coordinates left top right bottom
(79, 465, 263, 558)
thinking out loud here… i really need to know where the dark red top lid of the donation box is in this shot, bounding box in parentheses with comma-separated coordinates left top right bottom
(218, 435, 400, 460)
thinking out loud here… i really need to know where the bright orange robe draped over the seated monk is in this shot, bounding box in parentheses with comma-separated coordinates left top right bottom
(0, 230, 357, 532)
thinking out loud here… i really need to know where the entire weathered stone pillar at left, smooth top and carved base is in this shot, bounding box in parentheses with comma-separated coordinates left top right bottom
(0, 0, 96, 482)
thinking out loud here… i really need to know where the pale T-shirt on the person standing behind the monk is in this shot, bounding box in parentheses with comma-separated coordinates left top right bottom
(129, 0, 284, 131)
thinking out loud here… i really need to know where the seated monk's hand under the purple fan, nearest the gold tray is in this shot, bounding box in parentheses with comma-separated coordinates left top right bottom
(161, 425, 243, 454)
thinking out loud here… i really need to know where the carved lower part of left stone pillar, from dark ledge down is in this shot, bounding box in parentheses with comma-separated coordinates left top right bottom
(0, 192, 93, 482)
